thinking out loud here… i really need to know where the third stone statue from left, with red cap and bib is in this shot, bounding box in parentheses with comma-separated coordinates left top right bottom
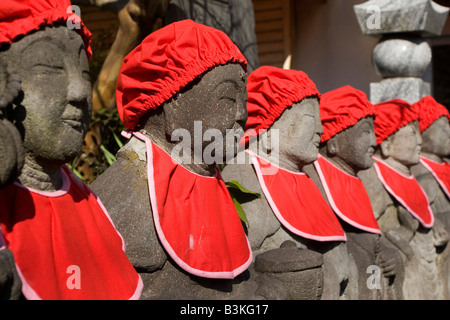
(223, 66, 357, 299)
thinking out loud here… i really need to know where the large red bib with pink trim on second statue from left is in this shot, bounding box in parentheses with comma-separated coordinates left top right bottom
(128, 132, 252, 279)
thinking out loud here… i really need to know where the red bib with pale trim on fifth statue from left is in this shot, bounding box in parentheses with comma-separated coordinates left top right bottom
(374, 159, 434, 228)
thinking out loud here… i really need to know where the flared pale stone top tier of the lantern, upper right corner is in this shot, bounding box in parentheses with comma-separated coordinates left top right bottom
(353, 0, 449, 36)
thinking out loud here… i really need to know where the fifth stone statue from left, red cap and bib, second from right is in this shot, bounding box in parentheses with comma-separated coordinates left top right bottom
(360, 99, 446, 299)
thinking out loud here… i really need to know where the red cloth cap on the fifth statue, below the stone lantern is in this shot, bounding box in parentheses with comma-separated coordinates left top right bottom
(374, 99, 419, 144)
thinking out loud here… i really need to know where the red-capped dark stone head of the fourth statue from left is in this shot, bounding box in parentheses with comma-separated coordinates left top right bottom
(320, 86, 376, 175)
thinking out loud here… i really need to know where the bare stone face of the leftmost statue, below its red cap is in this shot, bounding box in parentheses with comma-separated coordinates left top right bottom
(0, 26, 92, 165)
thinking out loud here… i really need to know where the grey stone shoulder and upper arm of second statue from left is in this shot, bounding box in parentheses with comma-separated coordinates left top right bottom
(91, 145, 167, 272)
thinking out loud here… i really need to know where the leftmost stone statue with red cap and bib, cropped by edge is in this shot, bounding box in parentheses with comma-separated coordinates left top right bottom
(0, 0, 142, 299)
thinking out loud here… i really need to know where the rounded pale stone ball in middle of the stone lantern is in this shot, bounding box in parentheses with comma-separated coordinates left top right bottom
(372, 39, 431, 78)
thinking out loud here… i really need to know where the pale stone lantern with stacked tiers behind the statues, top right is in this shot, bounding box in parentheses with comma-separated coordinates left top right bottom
(354, 0, 449, 103)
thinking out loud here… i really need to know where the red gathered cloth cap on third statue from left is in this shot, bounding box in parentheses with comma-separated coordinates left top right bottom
(245, 66, 320, 141)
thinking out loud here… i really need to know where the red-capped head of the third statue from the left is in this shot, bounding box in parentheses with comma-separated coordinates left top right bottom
(245, 66, 322, 170)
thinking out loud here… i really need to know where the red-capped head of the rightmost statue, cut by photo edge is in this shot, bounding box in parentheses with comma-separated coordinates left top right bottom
(414, 96, 450, 158)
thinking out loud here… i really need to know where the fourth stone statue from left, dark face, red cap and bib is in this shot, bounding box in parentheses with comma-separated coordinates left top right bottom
(305, 86, 402, 299)
